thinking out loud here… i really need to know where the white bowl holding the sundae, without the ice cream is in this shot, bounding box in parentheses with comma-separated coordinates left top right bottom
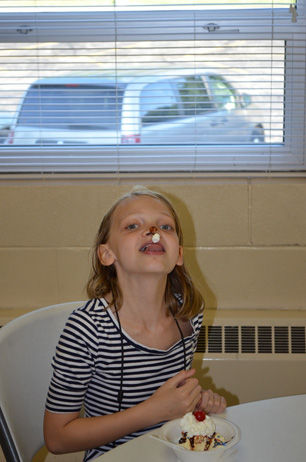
(154, 417, 240, 462)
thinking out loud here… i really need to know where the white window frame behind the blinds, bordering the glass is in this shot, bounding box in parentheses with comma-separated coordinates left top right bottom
(0, 0, 306, 173)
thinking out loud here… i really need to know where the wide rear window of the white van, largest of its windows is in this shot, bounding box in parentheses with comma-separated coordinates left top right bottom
(18, 84, 123, 130)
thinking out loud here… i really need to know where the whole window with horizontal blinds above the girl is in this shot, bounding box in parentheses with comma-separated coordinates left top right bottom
(0, 0, 306, 173)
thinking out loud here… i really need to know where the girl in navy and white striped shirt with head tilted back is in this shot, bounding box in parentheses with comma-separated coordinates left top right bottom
(44, 190, 226, 461)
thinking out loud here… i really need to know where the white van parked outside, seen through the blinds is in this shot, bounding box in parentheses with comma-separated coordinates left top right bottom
(6, 71, 265, 146)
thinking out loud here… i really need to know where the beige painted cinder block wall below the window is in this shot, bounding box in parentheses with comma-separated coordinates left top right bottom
(0, 178, 306, 324)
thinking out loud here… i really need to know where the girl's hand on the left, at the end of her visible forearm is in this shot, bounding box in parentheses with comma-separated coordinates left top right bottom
(148, 369, 202, 422)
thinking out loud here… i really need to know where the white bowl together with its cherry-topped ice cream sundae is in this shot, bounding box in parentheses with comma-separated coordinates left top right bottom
(152, 413, 240, 462)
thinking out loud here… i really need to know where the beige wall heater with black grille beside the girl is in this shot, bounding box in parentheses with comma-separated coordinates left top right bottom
(193, 310, 306, 405)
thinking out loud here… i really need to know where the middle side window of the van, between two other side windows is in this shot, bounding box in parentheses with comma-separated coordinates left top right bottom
(174, 76, 214, 116)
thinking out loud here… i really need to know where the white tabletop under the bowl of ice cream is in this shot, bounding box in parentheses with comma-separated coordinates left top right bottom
(95, 395, 306, 462)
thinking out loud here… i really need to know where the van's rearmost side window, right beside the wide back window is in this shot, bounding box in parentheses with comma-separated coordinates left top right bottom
(140, 81, 181, 125)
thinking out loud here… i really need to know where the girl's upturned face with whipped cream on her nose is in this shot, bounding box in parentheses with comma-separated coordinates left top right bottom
(98, 195, 183, 278)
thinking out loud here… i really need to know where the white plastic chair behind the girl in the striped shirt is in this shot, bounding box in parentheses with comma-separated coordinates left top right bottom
(0, 302, 84, 462)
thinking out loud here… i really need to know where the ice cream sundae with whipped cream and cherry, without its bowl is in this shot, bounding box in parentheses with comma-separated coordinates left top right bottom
(178, 411, 225, 451)
